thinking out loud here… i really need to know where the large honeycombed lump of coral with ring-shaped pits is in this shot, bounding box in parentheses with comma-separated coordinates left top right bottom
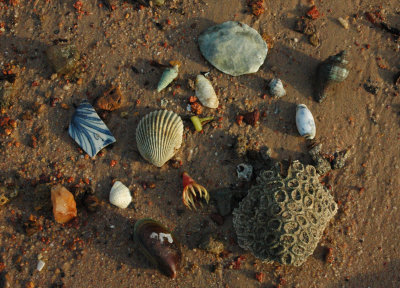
(233, 161, 337, 266)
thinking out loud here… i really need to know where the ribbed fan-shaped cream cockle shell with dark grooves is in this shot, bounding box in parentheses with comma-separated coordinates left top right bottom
(136, 110, 183, 167)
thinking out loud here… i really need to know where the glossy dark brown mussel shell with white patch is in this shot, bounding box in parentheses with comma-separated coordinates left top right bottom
(134, 218, 182, 278)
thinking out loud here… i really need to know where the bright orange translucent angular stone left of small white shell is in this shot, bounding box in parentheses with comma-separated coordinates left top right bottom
(51, 185, 77, 224)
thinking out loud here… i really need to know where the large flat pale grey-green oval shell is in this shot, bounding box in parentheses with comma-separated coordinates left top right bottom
(199, 21, 268, 76)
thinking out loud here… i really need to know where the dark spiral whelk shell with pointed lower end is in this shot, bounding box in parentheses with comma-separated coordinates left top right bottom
(314, 50, 349, 103)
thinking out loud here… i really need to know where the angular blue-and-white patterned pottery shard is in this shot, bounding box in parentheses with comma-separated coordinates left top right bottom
(68, 100, 116, 157)
